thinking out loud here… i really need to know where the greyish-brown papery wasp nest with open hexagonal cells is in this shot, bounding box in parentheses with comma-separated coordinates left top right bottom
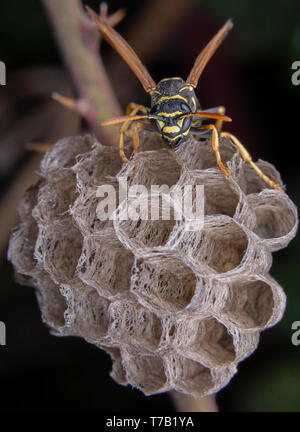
(8, 131, 297, 397)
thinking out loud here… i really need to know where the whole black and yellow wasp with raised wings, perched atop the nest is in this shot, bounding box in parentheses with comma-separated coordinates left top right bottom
(86, 7, 282, 191)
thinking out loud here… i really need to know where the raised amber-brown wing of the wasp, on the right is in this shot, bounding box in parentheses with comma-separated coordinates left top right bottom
(186, 18, 233, 87)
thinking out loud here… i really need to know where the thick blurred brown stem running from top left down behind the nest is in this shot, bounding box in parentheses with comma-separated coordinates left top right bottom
(44, 0, 121, 145)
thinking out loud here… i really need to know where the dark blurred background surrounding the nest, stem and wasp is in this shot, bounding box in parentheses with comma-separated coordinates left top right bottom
(0, 0, 300, 412)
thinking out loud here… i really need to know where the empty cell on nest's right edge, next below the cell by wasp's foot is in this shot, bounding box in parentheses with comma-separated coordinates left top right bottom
(223, 280, 275, 330)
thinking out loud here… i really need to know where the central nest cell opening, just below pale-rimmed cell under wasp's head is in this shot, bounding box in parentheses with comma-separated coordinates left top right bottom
(131, 256, 196, 313)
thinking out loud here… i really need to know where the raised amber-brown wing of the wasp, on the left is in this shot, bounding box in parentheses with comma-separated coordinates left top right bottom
(86, 6, 156, 93)
